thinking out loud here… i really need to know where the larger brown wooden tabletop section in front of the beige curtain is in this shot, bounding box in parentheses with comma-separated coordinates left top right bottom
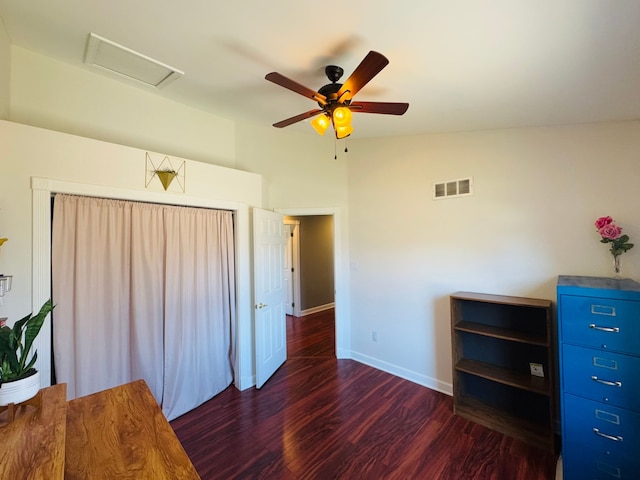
(65, 380, 200, 480)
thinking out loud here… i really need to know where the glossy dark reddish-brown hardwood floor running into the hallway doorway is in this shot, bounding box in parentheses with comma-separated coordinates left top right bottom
(171, 311, 556, 480)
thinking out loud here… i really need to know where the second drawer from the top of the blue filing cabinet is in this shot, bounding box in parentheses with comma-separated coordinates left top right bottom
(562, 345, 640, 411)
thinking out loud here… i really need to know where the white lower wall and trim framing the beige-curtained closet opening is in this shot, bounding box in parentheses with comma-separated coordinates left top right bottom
(0, 121, 262, 388)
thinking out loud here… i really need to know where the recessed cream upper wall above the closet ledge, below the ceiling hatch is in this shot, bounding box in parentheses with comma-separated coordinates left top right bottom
(9, 46, 235, 167)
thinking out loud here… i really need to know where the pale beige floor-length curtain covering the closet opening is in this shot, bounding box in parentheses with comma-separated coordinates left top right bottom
(51, 195, 235, 419)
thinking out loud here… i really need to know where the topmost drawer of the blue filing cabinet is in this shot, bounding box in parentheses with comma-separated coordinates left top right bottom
(560, 295, 640, 355)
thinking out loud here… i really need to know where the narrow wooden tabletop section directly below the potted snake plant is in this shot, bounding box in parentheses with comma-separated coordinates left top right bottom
(0, 384, 67, 480)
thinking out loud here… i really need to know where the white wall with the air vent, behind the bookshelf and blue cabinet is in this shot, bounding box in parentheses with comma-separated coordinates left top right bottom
(348, 121, 640, 392)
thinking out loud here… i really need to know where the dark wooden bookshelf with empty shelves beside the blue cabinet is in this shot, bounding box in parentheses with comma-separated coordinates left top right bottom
(450, 292, 556, 450)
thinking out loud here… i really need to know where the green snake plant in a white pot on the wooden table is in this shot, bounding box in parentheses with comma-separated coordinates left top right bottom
(0, 300, 53, 405)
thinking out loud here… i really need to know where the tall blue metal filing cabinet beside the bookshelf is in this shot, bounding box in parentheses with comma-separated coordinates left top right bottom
(557, 276, 640, 480)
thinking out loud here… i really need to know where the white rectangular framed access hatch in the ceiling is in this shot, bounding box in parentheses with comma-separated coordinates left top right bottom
(84, 33, 184, 88)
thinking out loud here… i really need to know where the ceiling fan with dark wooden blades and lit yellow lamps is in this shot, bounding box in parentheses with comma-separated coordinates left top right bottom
(265, 51, 409, 138)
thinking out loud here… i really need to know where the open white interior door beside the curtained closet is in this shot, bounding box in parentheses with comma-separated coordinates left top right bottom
(253, 208, 287, 388)
